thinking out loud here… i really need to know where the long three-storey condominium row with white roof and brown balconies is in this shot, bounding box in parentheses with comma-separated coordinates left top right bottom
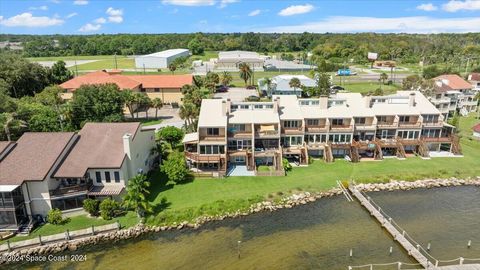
(183, 91, 461, 175)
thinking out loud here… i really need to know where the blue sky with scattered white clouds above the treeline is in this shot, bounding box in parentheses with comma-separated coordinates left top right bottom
(0, 0, 480, 34)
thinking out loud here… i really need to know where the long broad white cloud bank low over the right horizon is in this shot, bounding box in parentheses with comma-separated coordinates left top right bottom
(256, 16, 480, 33)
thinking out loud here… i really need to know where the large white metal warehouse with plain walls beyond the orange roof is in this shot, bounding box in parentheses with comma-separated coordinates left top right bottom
(135, 49, 190, 68)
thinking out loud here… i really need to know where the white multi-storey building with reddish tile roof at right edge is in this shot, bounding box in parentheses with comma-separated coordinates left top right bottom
(430, 74, 477, 119)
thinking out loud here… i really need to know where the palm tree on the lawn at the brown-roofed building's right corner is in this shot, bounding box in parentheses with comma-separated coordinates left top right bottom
(123, 174, 152, 218)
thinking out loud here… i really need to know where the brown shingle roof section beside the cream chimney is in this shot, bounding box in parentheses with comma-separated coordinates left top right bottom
(55, 122, 140, 177)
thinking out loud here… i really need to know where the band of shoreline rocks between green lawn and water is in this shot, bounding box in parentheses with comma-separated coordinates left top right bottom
(0, 176, 480, 265)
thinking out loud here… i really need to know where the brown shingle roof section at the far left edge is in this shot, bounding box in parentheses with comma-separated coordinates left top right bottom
(0, 132, 74, 185)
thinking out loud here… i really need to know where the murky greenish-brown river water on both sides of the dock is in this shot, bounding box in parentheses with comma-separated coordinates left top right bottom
(16, 186, 480, 270)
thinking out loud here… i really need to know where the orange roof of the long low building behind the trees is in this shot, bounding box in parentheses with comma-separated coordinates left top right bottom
(60, 70, 193, 90)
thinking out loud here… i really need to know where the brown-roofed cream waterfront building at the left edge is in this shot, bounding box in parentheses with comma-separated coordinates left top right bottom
(0, 122, 155, 231)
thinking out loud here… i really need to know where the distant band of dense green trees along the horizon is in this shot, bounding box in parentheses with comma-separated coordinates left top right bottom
(0, 33, 480, 64)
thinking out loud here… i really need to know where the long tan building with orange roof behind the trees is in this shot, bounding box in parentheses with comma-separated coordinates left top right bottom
(60, 70, 193, 104)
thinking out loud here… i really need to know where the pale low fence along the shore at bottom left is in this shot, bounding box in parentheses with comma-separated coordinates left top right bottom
(0, 222, 120, 252)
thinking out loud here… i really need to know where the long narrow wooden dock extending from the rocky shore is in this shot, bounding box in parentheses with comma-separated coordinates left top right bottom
(349, 187, 432, 269)
